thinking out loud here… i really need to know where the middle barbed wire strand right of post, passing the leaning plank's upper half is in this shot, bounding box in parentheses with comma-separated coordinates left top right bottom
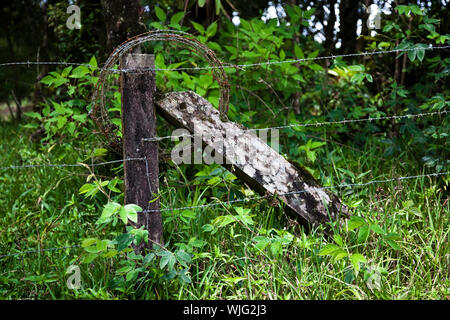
(142, 110, 450, 141)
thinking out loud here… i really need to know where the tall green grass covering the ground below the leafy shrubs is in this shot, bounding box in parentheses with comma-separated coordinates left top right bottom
(0, 123, 450, 299)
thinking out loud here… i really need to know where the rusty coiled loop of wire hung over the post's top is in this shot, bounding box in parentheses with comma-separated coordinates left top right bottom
(89, 30, 230, 153)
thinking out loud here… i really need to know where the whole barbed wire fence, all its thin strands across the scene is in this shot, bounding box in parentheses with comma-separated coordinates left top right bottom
(0, 40, 450, 259)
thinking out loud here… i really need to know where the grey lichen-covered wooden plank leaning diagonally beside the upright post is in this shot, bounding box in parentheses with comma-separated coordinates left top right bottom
(156, 92, 347, 225)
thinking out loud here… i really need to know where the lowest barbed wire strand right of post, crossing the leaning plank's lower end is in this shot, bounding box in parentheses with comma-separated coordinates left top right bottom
(139, 172, 450, 213)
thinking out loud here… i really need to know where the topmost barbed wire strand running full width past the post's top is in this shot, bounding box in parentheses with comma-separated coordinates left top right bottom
(0, 45, 450, 73)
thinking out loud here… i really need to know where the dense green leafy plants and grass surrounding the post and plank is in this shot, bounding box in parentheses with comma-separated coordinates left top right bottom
(0, 0, 450, 299)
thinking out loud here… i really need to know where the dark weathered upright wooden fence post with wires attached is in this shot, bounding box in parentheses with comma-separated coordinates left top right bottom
(120, 54, 163, 252)
